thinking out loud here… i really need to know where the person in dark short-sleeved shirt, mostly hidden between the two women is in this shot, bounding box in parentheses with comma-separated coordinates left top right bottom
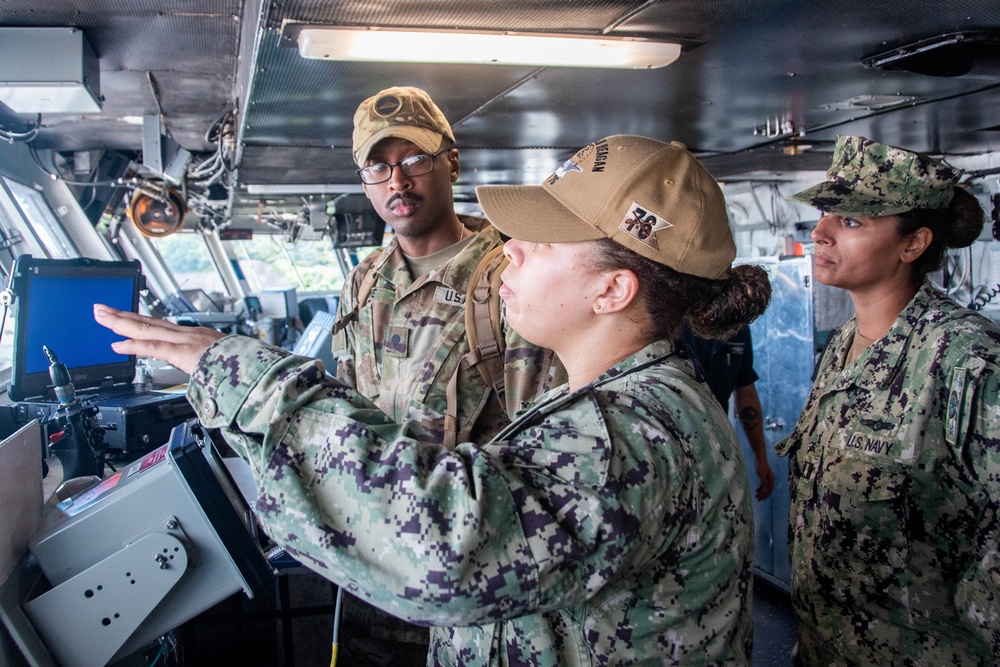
(684, 326, 774, 500)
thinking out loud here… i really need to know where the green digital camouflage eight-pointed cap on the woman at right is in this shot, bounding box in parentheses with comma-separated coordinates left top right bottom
(790, 136, 962, 218)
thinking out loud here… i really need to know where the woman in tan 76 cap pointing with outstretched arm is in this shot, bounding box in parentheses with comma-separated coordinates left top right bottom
(95, 135, 770, 666)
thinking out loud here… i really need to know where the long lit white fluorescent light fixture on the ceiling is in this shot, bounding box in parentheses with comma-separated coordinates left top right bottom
(298, 26, 681, 69)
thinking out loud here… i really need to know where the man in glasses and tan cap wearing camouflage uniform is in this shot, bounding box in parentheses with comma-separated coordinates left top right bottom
(333, 87, 565, 665)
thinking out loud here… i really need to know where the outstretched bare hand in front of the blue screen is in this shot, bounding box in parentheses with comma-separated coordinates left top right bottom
(94, 303, 226, 374)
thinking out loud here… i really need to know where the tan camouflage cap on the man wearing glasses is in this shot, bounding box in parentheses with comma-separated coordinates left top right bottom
(353, 86, 455, 167)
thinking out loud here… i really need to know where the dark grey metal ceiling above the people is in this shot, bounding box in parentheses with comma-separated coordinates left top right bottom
(0, 0, 1000, 226)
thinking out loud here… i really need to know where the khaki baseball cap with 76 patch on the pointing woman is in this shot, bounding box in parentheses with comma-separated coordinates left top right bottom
(476, 134, 736, 279)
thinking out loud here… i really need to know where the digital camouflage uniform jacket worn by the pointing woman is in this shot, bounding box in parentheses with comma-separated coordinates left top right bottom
(188, 337, 753, 666)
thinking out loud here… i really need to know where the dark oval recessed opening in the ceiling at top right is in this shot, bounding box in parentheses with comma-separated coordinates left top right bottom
(861, 30, 1000, 79)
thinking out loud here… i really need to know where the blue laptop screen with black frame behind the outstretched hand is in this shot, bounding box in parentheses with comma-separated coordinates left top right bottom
(8, 255, 142, 401)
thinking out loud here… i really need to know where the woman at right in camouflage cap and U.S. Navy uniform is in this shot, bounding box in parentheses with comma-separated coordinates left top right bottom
(778, 137, 1000, 667)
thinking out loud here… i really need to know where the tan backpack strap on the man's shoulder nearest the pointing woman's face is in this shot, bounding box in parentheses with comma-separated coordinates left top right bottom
(465, 245, 507, 403)
